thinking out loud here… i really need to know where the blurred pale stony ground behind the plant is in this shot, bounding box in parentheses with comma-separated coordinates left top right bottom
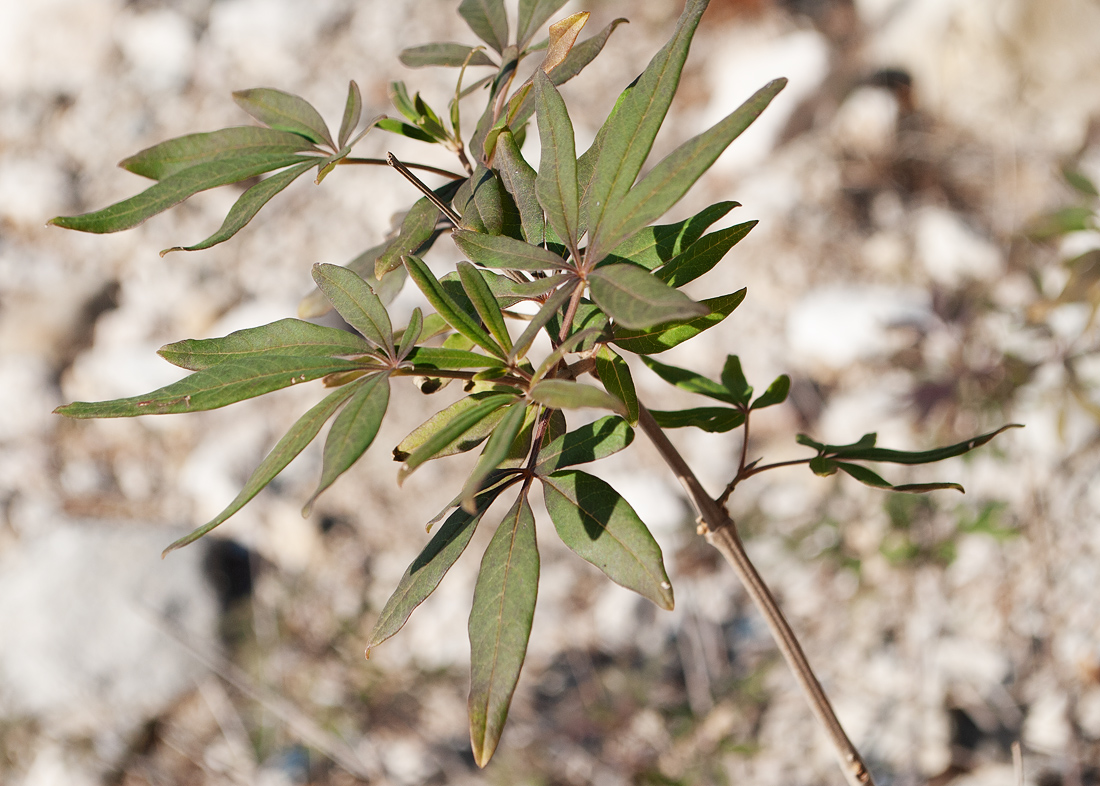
(0, 0, 1100, 786)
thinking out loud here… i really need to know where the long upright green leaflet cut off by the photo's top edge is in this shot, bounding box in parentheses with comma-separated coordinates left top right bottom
(587, 0, 707, 249)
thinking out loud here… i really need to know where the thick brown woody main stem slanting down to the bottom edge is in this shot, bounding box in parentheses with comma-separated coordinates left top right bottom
(638, 403, 875, 786)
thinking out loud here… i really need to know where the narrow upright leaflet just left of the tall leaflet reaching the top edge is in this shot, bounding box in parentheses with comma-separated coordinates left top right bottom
(534, 70, 581, 256)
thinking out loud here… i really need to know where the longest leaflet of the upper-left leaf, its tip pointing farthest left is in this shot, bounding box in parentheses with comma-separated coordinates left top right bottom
(50, 153, 318, 234)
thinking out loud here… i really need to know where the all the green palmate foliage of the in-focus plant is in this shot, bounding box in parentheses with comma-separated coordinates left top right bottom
(54, 0, 1012, 765)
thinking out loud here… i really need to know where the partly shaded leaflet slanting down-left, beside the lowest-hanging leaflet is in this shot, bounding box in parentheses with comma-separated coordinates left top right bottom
(366, 486, 506, 656)
